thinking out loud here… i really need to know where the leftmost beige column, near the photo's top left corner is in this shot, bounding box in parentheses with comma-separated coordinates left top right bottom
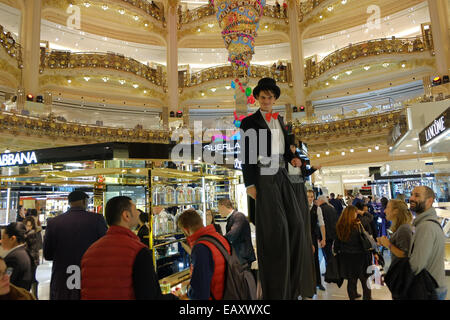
(19, 0, 42, 96)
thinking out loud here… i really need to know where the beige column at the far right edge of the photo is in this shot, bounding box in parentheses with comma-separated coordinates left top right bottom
(428, 0, 450, 77)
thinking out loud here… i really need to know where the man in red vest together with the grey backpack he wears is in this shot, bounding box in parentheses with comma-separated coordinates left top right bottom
(177, 209, 256, 300)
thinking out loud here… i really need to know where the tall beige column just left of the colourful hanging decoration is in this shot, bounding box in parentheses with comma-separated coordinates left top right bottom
(165, 0, 179, 113)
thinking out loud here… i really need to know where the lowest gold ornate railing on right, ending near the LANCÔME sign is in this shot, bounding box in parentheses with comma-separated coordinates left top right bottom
(292, 109, 406, 139)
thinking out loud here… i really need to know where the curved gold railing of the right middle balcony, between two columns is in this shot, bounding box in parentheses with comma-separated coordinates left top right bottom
(305, 36, 433, 80)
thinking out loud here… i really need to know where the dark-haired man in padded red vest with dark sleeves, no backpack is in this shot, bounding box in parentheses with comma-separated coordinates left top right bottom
(81, 196, 176, 300)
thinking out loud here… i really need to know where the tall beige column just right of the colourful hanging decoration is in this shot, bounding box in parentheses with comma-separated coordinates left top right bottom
(287, 0, 305, 107)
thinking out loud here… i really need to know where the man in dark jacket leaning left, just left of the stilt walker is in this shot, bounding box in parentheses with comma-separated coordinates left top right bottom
(218, 198, 256, 268)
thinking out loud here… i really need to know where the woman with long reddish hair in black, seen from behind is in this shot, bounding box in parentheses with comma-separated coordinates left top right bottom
(334, 205, 372, 300)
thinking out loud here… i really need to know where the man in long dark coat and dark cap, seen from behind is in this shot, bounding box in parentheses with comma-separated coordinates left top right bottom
(44, 191, 107, 300)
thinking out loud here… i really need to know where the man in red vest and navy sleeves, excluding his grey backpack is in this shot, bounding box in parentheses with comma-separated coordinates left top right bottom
(178, 209, 231, 300)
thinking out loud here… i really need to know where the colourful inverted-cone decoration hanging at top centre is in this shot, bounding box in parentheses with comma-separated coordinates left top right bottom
(210, 0, 266, 76)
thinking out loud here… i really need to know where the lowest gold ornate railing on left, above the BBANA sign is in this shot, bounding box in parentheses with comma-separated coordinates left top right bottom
(0, 112, 170, 143)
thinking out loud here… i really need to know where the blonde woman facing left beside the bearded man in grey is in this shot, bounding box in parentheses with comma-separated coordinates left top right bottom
(377, 200, 413, 265)
